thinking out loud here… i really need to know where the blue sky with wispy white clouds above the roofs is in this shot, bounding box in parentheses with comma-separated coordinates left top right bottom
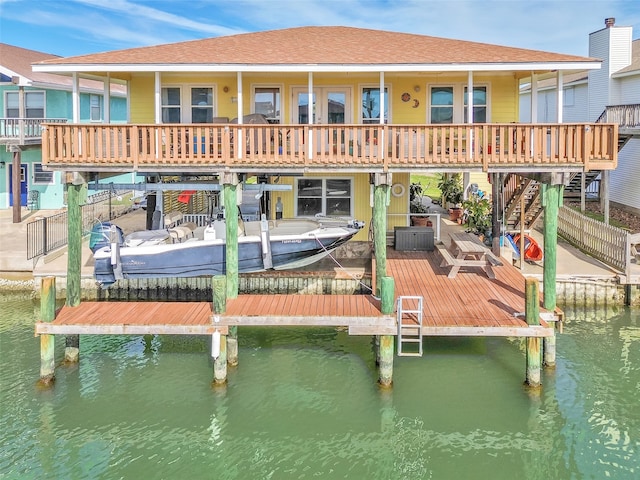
(0, 0, 640, 56)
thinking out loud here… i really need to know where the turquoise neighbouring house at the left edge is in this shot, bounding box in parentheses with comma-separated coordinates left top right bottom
(0, 43, 131, 209)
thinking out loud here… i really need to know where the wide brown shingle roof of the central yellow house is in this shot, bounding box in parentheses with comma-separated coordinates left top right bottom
(33, 27, 594, 65)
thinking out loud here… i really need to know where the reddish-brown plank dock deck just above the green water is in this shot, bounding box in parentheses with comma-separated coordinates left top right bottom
(35, 248, 553, 337)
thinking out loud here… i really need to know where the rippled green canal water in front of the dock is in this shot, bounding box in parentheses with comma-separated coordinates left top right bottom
(0, 294, 640, 479)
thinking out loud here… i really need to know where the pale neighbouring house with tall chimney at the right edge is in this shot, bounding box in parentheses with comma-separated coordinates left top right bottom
(520, 18, 640, 213)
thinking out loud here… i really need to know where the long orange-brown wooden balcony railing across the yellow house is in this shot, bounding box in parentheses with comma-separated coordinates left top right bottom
(42, 123, 617, 172)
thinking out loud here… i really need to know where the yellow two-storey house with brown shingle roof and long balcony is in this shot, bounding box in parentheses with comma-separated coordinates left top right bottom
(33, 27, 616, 244)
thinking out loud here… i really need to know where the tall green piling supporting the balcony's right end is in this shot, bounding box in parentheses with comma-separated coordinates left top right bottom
(542, 184, 564, 367)
